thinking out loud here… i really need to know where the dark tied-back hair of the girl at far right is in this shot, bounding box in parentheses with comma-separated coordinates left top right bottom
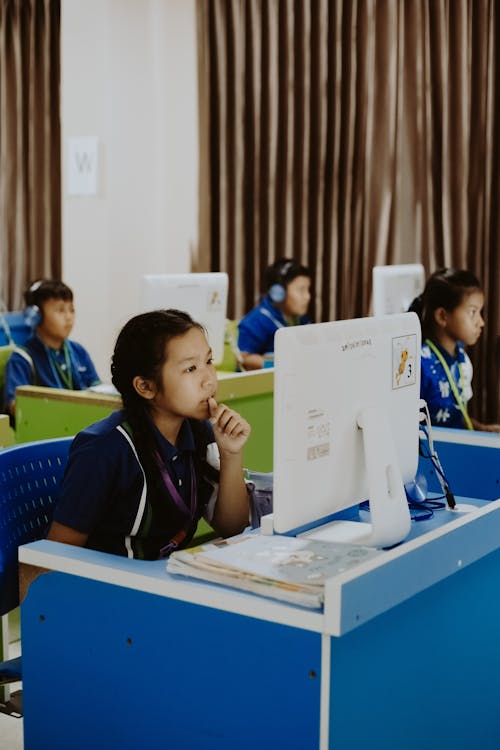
(408, 268, 481, 338)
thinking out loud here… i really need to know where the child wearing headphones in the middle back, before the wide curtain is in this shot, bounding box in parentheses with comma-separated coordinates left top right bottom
(238, 258, 311, 370)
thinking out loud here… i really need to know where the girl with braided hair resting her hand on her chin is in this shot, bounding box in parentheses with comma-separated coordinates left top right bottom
(48, 310, 250, 559)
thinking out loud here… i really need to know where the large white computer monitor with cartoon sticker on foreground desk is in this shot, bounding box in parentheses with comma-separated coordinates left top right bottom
(273, 313, 421, 547)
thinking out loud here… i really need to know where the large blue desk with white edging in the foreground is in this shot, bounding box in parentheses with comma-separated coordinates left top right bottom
(20, 500, 500, 750)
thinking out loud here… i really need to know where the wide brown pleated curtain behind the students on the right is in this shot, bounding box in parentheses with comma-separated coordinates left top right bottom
(197, 0, 500, 421)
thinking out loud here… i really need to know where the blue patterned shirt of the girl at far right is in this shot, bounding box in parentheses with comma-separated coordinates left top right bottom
(420, 342, 472, 428)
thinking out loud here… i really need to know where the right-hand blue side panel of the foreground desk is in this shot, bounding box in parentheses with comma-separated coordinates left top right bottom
(330, 551, 500, 750)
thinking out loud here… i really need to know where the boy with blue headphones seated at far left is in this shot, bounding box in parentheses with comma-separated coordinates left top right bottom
(4, 279, 100, 416)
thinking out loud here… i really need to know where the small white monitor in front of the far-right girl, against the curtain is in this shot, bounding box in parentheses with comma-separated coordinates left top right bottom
(372, 263, 425, 315)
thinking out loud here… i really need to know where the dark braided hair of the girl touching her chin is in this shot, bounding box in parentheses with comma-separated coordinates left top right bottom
(111, 310, 205, 492)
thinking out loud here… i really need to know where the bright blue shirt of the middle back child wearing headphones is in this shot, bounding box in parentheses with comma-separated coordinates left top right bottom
(238, 296, 311, 354)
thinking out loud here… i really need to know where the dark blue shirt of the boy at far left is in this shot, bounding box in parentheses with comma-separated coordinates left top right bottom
(4, 336, 101, 406)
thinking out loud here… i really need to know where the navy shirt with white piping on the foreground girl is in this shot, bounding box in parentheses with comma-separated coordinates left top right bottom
(54, 411, 220, 560)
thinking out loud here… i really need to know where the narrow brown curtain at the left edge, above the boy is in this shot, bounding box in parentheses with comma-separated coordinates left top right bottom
(0, 0, 61, 310)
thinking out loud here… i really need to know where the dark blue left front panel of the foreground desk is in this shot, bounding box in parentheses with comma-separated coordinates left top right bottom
(22, 563, 321, 750)
